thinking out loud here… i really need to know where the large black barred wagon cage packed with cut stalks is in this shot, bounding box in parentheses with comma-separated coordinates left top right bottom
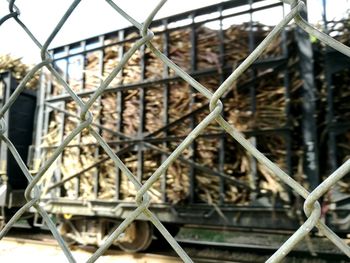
(35, 1, 319, 229)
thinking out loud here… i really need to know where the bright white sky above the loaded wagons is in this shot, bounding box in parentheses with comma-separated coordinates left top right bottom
(0, 0, 350, 63)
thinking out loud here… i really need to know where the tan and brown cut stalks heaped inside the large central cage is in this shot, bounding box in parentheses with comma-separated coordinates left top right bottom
(36, 2, 302, 209)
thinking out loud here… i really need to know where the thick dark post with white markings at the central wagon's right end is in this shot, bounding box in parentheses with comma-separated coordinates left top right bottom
(296, 5, 320, 190)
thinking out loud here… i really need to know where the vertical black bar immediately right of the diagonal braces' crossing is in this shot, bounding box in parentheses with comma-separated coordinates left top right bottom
(161, 19, 169, 202)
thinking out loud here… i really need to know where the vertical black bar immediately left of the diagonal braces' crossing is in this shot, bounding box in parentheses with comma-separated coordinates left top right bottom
(115, 30, 125, 201)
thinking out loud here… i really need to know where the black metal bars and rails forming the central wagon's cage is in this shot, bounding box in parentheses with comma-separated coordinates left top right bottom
(33, 0, 319, 231)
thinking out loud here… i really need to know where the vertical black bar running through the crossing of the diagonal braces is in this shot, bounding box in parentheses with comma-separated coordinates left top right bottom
(137, 40, 146, 182)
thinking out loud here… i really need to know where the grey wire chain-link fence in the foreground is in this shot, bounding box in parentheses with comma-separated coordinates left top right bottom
(0, 0, 350, 262)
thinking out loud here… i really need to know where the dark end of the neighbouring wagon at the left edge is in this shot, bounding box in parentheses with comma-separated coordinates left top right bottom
(0, 71, 36, 209)
